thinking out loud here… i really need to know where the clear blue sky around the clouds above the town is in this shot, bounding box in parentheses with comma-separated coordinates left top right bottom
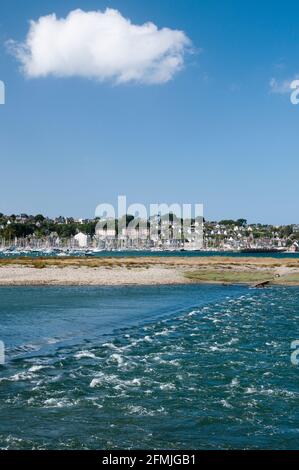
(0, 0, 299, 224)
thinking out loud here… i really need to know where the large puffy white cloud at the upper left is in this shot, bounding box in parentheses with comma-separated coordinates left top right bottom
(9, 9, 191, 84)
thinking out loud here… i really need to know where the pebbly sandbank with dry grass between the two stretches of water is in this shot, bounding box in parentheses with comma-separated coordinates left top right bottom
(0, 257, 299, 286)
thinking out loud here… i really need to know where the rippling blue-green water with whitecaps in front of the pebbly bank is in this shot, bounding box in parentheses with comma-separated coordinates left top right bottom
(0, 285, 299, 449)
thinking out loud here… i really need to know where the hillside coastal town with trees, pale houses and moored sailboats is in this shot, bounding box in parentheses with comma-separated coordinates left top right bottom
(0, 214, 299, 253)
